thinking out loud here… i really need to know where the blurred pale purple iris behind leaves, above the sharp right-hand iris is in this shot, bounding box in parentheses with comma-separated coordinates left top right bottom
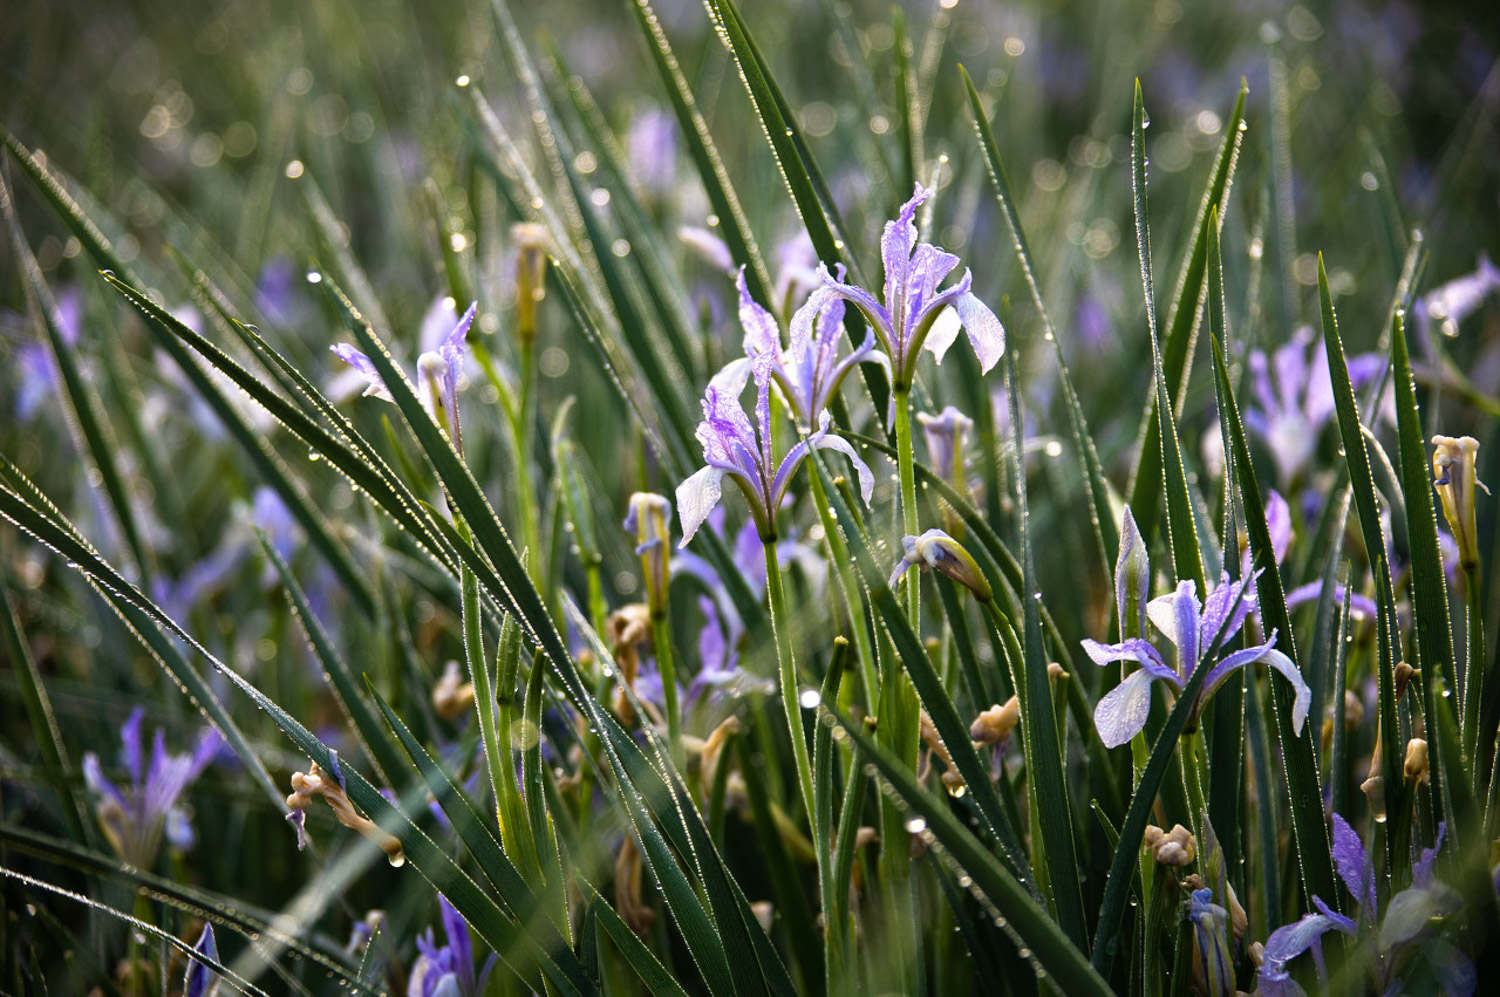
(1245, 325, 1395, 484)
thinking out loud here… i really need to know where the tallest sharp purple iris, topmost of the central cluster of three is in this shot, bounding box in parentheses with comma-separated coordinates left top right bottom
(804, 184, 1005, 388)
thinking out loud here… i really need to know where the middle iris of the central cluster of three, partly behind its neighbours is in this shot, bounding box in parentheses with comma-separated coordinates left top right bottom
(737, 267, 891, 426)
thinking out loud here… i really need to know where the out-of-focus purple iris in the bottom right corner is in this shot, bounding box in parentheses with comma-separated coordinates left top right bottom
(1257, 814, 1478, 997)
